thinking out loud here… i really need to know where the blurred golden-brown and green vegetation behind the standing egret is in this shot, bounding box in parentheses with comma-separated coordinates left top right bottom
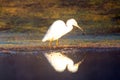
(0, 0, 120, 34)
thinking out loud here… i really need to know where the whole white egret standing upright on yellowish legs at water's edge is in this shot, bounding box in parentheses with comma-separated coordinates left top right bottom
(42, 19, 83, 46)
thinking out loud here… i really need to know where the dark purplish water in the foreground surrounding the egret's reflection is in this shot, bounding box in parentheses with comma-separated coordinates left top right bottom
(0, 48, 120, 80)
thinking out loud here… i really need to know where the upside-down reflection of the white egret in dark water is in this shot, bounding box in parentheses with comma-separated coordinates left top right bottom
(44, 52, 83, 73)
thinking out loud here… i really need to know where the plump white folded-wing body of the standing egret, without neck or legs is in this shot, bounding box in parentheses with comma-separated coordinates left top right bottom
(42, 20, 66, 42)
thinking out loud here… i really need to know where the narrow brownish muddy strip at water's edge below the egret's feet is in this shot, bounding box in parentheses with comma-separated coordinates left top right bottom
(0, 46, 120, 54)
